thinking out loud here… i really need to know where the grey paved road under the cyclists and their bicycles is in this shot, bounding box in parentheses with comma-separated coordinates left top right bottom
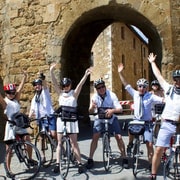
(0, 116, 166, 180)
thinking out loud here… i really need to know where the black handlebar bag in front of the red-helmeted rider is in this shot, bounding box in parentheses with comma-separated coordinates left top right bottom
(11, 112, 30, 128)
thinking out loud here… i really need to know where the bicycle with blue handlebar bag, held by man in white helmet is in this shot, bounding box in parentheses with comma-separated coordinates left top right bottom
(128, 120, 145, 177)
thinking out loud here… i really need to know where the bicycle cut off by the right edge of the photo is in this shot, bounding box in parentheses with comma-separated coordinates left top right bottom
(163, 130, 180, 180)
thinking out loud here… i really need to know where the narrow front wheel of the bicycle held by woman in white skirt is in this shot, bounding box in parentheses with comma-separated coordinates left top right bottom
(59, 137, 71, 179)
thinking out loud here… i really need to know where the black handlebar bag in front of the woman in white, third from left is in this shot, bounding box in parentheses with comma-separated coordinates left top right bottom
(61, 106, 77, 119)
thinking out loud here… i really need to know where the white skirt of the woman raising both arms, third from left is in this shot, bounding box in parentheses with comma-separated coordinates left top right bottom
(56, 118, 79, 133)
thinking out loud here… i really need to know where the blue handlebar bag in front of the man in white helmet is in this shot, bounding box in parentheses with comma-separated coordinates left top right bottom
(128, 124, 145, 135)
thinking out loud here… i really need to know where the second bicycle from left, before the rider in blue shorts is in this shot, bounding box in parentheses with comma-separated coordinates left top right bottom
(33, 115, 56, 167)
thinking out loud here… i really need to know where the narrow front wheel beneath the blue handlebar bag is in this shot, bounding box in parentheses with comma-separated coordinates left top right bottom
(132, 140, 139, 177)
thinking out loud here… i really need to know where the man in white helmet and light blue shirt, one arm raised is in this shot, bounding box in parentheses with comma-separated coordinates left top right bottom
(118, 63, 163, 170)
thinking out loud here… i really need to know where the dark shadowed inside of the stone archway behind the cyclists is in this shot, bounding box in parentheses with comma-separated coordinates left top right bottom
(61, 2, 162, 125)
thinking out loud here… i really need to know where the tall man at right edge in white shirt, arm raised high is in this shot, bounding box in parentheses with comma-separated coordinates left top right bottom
(148, 53, 180, 180)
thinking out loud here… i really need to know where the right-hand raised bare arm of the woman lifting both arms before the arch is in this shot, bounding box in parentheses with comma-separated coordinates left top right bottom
(74, 68, 91, 99)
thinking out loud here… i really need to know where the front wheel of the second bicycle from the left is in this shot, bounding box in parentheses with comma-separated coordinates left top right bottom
(35, 132, 53, 167)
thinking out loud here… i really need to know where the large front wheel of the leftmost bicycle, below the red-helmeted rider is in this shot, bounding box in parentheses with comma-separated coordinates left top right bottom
(4, 141, 41, 180)
